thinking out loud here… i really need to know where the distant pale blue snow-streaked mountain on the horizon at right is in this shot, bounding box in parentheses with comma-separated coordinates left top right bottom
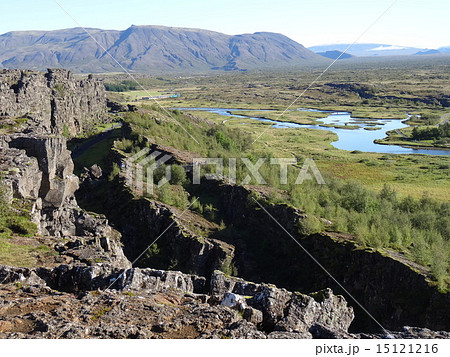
(308, 43, 424, 57)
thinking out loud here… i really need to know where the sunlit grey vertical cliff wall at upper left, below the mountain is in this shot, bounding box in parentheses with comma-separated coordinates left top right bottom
(0, 69, 106, 136)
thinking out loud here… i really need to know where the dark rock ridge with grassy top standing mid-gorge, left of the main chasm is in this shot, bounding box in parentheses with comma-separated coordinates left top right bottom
(100, 184, 234, 276)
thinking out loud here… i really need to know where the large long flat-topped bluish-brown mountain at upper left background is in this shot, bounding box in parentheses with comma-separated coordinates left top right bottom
(0, 26, 320, 72)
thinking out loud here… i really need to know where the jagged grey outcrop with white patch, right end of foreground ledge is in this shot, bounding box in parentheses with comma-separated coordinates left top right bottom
(211, 271, 354, 334)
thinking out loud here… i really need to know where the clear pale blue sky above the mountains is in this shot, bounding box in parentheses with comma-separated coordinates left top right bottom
(0, 0, 450, 48)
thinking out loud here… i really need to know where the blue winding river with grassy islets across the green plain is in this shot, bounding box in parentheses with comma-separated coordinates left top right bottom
(177, 108, 450, 155)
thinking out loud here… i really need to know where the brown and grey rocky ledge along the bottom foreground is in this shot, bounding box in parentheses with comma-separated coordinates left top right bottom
(0, 265, 356, 339)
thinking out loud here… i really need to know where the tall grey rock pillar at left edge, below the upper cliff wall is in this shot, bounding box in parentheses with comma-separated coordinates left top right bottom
(0, 134, 79, 236)
